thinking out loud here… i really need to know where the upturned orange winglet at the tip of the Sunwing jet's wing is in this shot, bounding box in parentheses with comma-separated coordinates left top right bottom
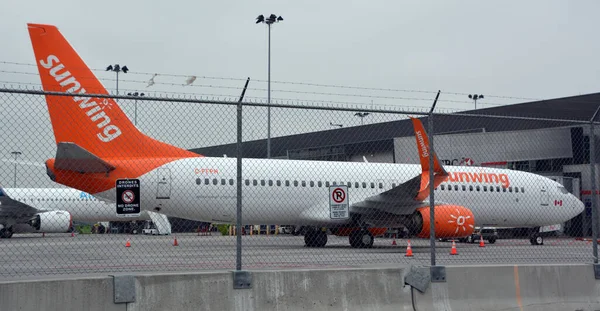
(411, 117, 448, 201)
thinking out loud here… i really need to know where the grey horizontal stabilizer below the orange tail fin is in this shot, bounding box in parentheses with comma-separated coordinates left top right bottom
(54, 142, 115, 173)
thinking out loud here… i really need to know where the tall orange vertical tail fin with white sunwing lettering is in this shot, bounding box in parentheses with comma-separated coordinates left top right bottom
(28, 24, 199, 158)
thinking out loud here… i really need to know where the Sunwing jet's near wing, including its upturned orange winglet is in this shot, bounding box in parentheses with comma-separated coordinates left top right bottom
(350, 118, 448, 219)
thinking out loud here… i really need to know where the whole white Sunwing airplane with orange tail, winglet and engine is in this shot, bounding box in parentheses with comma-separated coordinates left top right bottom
(28, 24, 584, 248)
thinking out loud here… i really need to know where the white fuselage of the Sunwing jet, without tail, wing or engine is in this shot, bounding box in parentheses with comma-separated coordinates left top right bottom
(91, 158, 583, 227)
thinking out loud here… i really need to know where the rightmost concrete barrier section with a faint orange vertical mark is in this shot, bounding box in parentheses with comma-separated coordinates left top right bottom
(414, 264, 600, 311)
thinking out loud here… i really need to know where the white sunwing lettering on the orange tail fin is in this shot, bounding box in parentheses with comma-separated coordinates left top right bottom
(40, 55, 121, 143)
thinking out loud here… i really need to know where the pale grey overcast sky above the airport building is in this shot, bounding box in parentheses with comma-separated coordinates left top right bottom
(0, 0, 600, 188)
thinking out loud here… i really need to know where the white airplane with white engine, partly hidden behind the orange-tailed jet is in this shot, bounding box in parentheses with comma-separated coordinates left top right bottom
(0, 187, 171, 238)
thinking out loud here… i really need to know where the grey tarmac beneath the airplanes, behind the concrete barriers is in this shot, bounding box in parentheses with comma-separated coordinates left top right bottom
(0, 233, 593, 280)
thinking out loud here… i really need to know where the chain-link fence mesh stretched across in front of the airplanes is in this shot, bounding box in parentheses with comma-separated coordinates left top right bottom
(0, 89, 597, 278)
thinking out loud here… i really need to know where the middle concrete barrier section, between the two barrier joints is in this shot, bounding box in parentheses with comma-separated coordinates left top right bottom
(127, 268, 412, 311)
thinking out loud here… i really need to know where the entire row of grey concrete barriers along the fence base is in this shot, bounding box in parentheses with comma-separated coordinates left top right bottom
(0, 264, 600, 311)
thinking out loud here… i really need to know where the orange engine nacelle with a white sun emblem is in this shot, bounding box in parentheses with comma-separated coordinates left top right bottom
(408, 205, 475, 238)
